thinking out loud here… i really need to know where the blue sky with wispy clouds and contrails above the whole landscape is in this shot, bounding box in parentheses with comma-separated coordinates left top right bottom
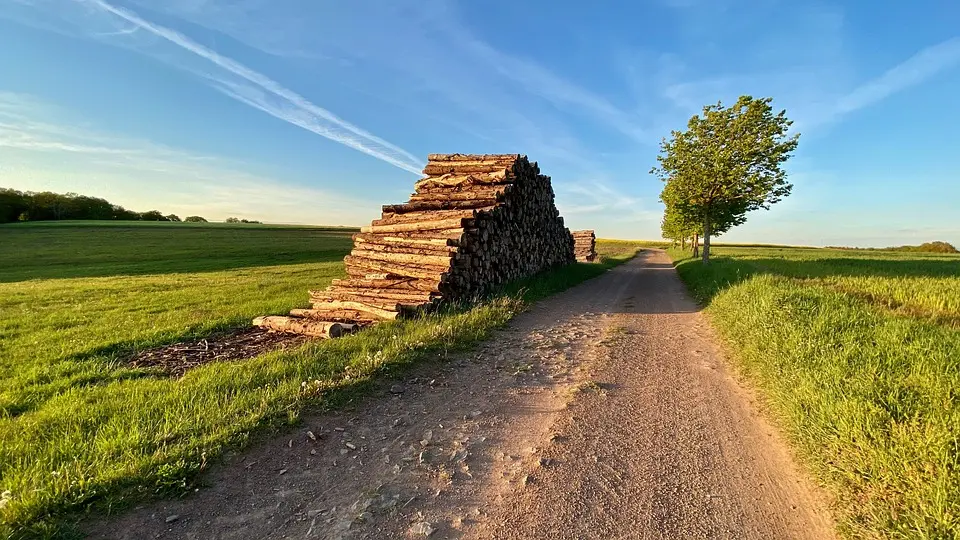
(0, 0, 960, 246)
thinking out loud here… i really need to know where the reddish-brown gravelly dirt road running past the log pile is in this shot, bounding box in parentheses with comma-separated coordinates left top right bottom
(94, 251, 834, 539)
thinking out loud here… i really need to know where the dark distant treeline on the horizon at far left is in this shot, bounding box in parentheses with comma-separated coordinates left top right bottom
(0, 188, 207, 223)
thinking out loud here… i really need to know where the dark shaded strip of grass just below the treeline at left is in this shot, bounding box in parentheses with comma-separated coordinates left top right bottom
(0, 221, 357, 283)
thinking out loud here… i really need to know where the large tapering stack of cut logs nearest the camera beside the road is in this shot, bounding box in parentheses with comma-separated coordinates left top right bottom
(254, 154, 575, 337)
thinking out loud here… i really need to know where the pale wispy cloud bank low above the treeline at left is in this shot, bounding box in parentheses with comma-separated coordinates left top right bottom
(0, 92, 378, 225)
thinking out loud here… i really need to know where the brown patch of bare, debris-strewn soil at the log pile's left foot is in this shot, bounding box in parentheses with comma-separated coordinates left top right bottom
(123, 327, 309, 377)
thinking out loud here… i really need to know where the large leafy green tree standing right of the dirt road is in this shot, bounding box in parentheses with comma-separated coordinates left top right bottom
(651, 96, 800, 262)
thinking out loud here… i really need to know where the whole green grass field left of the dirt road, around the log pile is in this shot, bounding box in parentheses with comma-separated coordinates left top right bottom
(0, 219, 637, 537)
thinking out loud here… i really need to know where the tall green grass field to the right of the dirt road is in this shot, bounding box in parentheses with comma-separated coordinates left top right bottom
(673, 247, 960, 538)
